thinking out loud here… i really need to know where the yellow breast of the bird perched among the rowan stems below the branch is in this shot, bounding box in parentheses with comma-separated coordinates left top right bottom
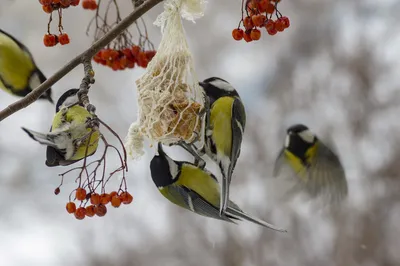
(52, 105, 100, 160)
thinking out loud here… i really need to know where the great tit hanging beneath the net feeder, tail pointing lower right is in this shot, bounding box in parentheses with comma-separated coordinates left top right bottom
(150, 143, 286, 232)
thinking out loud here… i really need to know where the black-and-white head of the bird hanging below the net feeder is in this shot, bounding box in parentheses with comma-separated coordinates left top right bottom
(150, 143, 180, 188)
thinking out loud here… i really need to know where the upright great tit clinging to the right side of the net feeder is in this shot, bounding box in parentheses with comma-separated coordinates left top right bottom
(199, 77, 246, 215)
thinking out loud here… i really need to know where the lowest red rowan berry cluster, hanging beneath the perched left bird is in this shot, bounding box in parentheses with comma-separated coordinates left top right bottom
(66, 187, 133, 220)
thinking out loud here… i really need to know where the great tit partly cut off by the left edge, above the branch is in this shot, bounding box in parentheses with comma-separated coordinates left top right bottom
(0, 29, 53, 103)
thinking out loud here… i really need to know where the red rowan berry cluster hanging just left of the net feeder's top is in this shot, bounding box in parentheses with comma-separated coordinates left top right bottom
(93, 45, 156, 71)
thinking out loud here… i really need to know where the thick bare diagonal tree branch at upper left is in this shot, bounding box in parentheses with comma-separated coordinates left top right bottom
(0, 0, 163, 121)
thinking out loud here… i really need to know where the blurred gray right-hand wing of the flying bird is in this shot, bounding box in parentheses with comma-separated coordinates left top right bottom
(307, 142, 348, 202)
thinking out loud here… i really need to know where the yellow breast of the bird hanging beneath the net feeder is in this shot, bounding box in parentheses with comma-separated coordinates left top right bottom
(176, 164, 220, 206)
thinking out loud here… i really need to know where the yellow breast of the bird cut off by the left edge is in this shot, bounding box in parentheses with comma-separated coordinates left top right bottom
(0, 33, 35, 91)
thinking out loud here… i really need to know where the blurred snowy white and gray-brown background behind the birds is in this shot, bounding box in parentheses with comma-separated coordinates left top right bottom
(0, 0, 400, 266)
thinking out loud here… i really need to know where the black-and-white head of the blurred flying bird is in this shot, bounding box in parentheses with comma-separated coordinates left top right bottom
(285, 124, 318, 159)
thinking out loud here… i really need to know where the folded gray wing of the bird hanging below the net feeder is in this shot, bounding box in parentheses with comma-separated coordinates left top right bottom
(166, 185, 238, 223)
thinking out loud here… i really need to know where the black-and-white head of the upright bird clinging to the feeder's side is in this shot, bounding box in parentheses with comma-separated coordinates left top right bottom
(199, 77, 239, 104)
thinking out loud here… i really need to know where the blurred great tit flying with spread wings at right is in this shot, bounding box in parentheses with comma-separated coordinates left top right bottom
(273, 124, 348, 202)
